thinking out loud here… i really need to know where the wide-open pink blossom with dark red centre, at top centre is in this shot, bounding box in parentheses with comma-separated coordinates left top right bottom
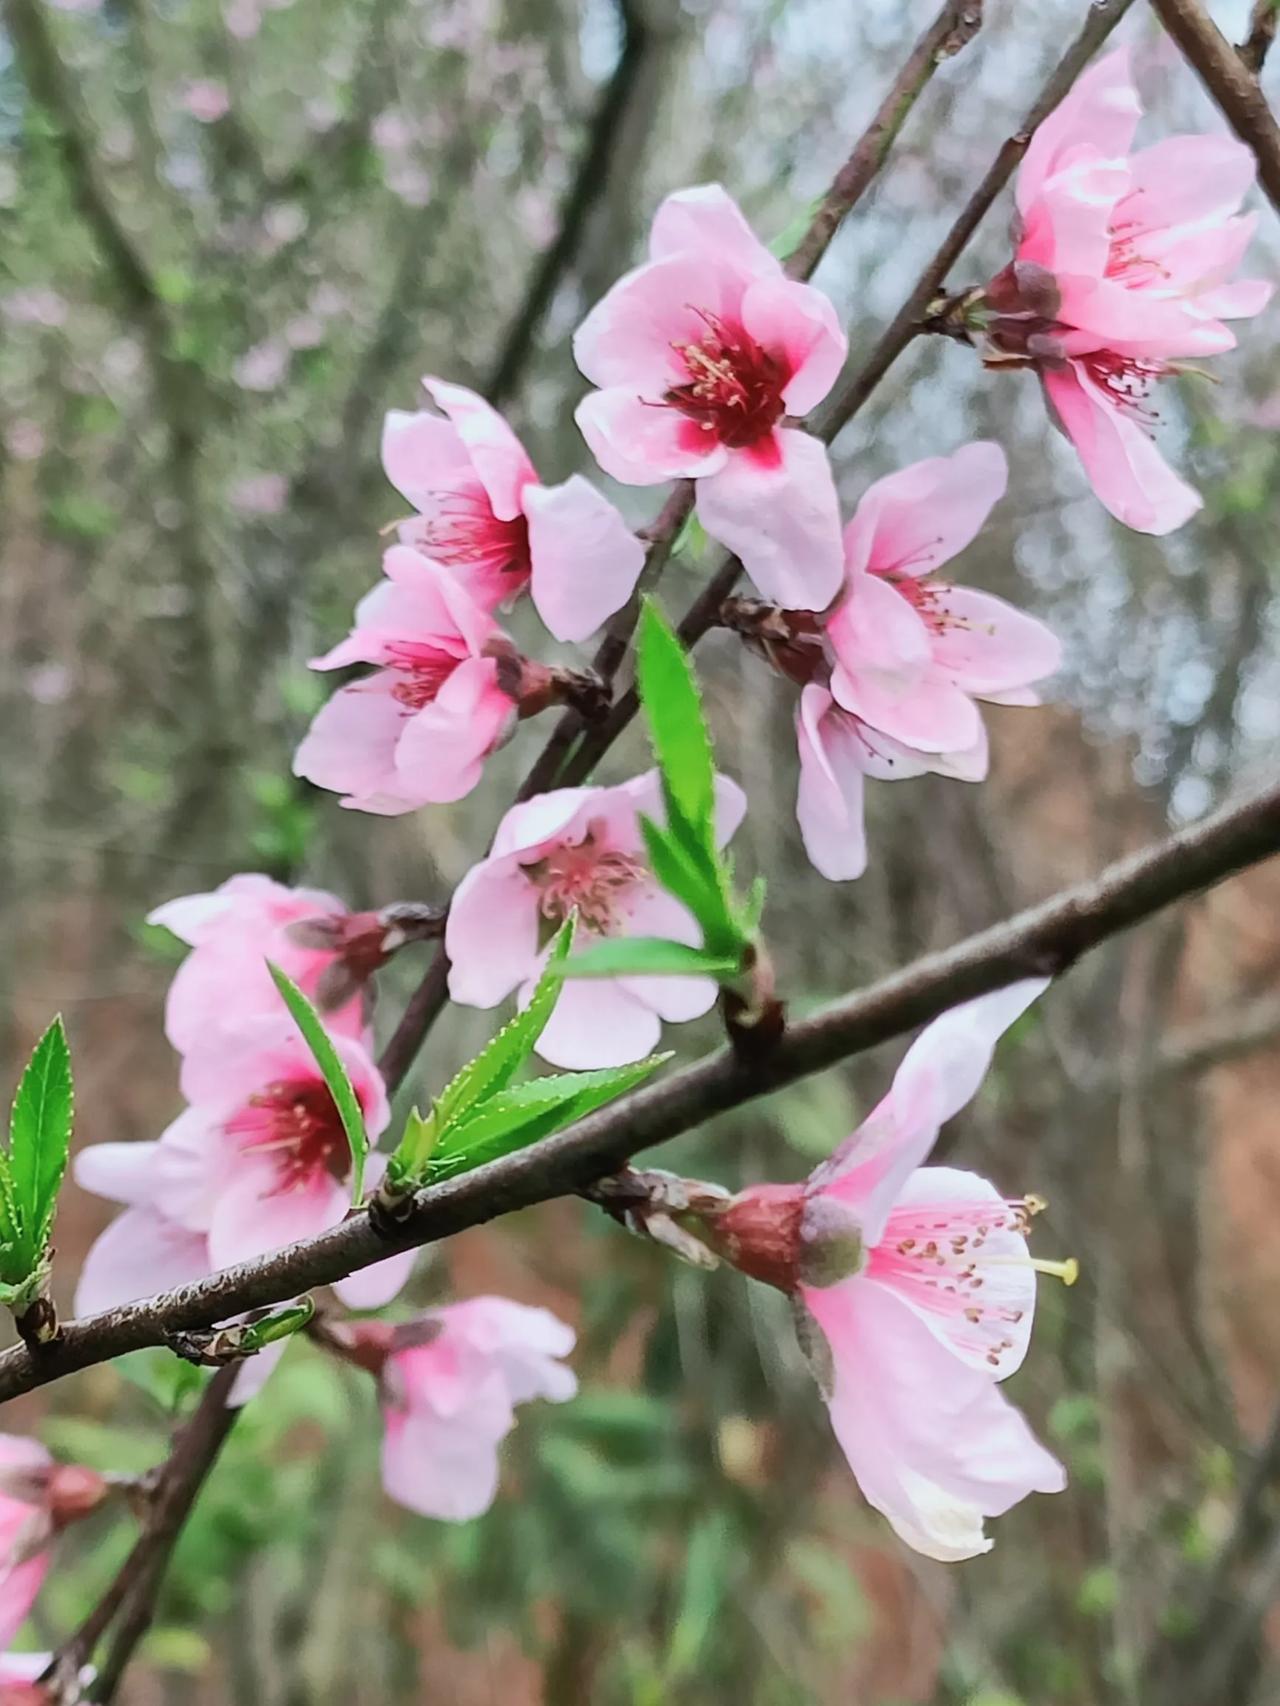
(573, 184, 847, 609)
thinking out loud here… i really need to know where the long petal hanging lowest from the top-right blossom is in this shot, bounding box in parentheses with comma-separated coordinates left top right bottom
(1043, 362, 1201, 534)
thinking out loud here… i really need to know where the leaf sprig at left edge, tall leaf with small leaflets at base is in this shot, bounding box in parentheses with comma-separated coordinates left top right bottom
(0, 1015, 75, 1312)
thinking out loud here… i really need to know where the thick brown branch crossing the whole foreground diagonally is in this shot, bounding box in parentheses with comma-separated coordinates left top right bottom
(0, 783, 1280, 1401)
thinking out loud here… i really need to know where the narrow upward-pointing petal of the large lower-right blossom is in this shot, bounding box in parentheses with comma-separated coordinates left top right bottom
(809, 978, 1050, 1249)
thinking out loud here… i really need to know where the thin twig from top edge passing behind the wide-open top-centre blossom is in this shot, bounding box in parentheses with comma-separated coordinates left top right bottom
(382, 0, 996, 1088)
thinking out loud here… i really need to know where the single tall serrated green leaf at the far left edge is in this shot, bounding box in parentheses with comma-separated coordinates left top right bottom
(3, 1017, 73, 1280)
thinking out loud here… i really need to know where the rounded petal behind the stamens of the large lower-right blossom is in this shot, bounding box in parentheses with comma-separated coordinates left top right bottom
(865, 1167, 1036, 1380)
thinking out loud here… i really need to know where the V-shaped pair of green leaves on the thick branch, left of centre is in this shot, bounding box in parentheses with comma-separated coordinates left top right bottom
(387, 918, 669, 1191)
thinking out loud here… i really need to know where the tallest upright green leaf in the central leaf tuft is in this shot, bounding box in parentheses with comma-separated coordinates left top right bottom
(637, 599, 715, 851)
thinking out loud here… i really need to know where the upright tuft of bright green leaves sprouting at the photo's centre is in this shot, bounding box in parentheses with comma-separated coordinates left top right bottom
(565, 601, 765, 983)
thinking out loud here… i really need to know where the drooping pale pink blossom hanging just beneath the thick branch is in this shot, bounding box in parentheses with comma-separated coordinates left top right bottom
(375, 1297, 577, 1522)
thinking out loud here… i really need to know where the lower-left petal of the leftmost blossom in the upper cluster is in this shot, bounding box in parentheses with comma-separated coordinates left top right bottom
(294, 670, 427, 817)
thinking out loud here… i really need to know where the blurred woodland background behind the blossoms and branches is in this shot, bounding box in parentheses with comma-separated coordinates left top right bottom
(0, 0, 1280, 1706)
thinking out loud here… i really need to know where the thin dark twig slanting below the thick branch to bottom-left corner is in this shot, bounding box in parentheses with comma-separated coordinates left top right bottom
(44, 1363, 239, 1706)
